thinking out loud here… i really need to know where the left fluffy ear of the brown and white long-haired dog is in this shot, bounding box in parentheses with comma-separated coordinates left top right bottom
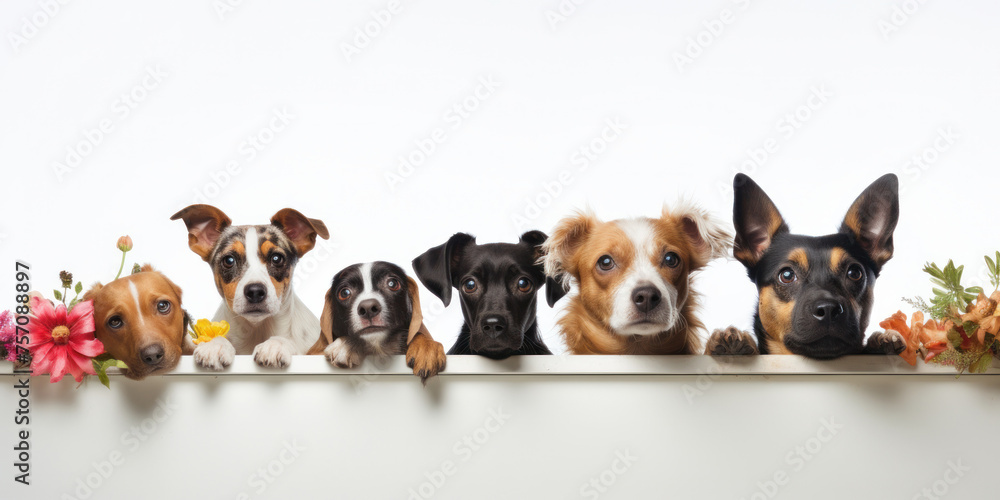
(542, 210, 600, 307)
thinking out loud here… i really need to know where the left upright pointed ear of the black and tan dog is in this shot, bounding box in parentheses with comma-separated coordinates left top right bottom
(733, 174, 788, 268)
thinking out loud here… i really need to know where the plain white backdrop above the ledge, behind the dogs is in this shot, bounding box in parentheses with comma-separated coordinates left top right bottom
(0, 0, 1000, 352)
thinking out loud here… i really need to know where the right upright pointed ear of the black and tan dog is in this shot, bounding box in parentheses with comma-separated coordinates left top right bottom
(840, 174, 899, 268)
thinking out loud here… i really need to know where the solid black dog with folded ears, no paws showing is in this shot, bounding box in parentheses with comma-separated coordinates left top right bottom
(413, 231, 565, 359)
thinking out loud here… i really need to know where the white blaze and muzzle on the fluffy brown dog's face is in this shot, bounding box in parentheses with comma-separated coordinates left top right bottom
(610, 219, 679, 335)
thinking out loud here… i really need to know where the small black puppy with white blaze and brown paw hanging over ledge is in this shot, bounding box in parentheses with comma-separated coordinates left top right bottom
(309, 261, 446, 382)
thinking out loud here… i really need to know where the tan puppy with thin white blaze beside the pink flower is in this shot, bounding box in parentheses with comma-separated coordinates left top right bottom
(83, 264, 194, 380)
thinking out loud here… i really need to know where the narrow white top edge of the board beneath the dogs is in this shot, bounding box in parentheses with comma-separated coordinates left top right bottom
(0, 355, 988, 377)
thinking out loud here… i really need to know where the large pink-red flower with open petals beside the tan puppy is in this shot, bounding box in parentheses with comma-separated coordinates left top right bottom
(28, 296, 104, 383)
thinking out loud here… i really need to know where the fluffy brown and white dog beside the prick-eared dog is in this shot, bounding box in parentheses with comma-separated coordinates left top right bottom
(544, 203, 732, 354)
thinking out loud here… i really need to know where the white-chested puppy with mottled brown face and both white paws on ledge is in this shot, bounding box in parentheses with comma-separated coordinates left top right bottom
(170, 205, 330, 370)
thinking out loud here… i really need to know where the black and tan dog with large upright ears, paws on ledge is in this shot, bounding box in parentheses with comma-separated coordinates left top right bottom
(706, 174, 905, 359)
